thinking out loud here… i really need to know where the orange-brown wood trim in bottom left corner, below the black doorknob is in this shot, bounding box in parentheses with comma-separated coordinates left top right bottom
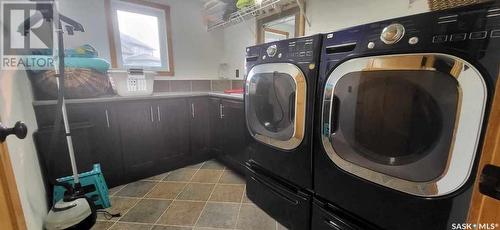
(0, 119, 26, 230)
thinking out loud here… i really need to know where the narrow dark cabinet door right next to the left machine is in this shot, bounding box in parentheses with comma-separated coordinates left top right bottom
(222, 100, 249, 170)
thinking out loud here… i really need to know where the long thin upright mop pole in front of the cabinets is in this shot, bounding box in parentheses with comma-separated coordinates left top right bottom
(53, 2, 80, 184)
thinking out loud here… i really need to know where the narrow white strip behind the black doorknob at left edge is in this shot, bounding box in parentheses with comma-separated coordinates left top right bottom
(0, 71, 47, 230)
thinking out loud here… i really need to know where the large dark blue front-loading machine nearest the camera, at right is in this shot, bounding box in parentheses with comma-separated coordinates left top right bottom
(312, 1, 500, 229)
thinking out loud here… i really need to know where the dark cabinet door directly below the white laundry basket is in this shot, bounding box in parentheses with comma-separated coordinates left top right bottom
(114, 101, 157, 180)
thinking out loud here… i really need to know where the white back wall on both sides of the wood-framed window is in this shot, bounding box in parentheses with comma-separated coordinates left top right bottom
(58, 0, 224, 78)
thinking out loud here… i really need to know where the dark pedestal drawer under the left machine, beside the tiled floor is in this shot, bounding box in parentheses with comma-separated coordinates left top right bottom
(247, 166, 311, 230)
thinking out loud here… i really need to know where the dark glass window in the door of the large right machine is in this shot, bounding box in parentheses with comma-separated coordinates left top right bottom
(331, 70, 458, 181)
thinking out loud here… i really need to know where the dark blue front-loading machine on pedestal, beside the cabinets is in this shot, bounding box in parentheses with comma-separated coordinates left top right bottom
(244, 35, 322, 230)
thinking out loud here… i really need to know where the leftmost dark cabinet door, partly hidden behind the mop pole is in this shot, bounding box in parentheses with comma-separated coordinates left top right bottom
(35, 103, 122, 187)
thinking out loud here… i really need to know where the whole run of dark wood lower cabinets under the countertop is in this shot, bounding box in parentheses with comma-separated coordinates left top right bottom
(34, 97, 249, 187)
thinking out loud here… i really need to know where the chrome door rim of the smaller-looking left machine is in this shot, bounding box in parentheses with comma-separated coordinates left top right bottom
(245, 63, 307, 150)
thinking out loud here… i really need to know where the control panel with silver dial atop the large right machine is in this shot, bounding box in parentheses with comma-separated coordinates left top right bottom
(323, 1, 500, 59)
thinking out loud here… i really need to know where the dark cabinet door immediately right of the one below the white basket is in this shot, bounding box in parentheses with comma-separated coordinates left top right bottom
(156, 99, 191, 170)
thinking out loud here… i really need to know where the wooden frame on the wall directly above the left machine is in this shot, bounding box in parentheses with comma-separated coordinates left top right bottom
(255, 5, 305, 44)
